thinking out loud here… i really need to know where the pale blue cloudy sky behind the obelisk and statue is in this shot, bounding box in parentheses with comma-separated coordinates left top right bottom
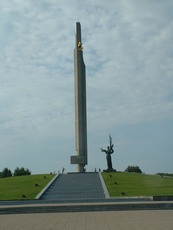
(0, 0, 173, 174)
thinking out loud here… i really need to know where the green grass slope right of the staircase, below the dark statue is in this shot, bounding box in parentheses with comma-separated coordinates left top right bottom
(102, 172, 173, 197)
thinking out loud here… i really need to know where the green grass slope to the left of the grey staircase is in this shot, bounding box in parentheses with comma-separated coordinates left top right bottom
(0, 174, 55, 200)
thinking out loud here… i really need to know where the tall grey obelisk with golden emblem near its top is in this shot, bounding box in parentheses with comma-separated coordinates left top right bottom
(71, 22, 87, 172)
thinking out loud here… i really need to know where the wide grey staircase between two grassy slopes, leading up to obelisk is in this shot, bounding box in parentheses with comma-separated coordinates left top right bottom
(40, 173, 105, 201)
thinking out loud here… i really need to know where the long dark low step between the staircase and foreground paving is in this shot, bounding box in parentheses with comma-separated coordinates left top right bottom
(0, 202, 173, 215)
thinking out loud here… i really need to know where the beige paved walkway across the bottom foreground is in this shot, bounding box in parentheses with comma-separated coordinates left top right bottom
(0, 210, 173, 230)
